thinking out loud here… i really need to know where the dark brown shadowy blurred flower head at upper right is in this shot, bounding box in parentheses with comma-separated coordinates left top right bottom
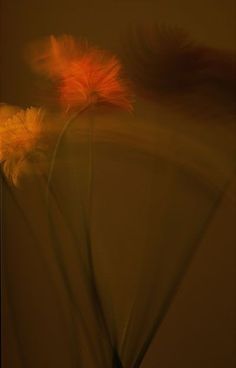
(124, 26, 236, 115)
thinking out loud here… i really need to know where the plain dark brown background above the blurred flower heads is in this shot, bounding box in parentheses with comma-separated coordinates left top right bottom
(1, 0, 235, 104)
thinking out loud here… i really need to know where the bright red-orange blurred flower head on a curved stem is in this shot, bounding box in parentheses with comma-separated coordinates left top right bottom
(28, 36, 132, 111)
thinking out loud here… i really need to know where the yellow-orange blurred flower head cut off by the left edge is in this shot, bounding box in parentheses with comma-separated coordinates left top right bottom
(0, 106, 44, 185)
